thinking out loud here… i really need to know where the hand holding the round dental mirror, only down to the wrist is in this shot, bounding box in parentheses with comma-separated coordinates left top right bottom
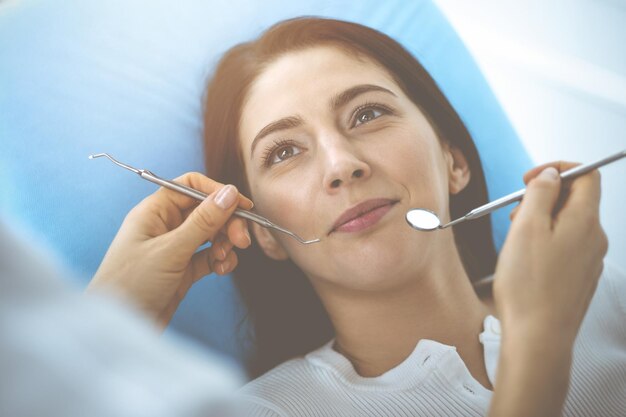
(494, 162, 608, 343)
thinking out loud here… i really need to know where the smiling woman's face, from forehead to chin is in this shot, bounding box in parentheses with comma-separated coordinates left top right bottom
(239, 46, 469, 290)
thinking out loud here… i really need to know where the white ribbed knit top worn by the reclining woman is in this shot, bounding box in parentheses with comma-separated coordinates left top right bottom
(233, 265, 626, 417)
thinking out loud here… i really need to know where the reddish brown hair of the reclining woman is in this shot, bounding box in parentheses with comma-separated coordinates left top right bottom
(204, 18, 496, 377)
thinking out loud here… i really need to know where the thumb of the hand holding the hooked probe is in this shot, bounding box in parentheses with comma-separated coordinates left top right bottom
(173, 185, 239, 249)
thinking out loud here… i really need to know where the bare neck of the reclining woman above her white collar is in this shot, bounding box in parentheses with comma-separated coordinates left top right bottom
(318, 252, 490, 378)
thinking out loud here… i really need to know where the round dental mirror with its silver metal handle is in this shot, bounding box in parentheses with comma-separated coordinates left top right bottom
(406, 149, 626, 231)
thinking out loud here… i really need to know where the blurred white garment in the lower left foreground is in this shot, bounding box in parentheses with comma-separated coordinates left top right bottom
(0, 220, 243, 417)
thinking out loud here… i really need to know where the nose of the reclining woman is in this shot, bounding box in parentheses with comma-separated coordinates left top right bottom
(324, 141, 371, 192)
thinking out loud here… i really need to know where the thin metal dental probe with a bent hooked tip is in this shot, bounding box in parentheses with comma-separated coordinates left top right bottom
(89, 153, 320, 245)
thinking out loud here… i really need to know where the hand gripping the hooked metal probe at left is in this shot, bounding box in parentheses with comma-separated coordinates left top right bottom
(87, 173, 252, 327)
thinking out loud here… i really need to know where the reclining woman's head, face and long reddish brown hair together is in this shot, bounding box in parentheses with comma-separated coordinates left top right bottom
(205, 19, 496, 375)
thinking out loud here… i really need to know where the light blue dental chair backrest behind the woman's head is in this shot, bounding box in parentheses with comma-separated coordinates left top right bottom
(0, 0, 531, 364)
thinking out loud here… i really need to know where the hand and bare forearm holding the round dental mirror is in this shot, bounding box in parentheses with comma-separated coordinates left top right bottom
(489, 162, 608, 417)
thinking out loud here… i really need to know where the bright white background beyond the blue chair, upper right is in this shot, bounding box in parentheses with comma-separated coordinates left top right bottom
(435, 0, 626, 271)
